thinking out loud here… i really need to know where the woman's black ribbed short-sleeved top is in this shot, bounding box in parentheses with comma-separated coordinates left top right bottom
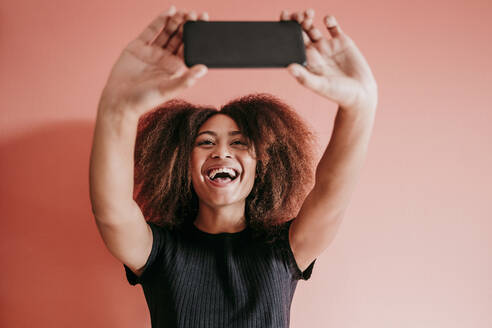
(124, 221, 316, 328)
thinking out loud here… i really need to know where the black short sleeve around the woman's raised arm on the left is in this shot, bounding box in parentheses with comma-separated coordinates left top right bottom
(123, 222, 166, 286)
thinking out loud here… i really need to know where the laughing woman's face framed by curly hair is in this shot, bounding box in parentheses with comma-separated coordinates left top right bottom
(190, 114, 256, 207)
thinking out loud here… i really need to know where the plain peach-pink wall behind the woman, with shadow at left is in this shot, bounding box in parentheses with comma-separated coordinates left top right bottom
(0, 0, 492, 328)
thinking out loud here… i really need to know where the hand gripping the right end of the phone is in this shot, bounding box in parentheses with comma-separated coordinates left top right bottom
(280, 9, 378, 111)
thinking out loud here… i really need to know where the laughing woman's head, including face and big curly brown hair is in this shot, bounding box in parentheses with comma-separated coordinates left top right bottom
(134, 93, 316, 241)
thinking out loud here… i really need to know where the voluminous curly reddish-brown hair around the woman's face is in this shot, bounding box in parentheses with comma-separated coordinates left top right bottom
(134, 93, 316, 241)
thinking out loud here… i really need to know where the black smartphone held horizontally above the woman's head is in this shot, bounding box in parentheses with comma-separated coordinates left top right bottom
(183, 20, 306, 68)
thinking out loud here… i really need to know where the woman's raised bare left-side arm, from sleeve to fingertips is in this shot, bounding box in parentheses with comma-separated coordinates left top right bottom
(89, 7, 208, 271)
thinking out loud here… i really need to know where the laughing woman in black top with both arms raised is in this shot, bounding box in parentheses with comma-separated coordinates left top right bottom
(90, 3, 377, 327)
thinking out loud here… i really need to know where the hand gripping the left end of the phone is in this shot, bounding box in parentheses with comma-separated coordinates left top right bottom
(100, 6, 208, 116)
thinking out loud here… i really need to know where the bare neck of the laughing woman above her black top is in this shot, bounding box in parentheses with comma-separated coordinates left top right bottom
(194, 202, 246, 234)
